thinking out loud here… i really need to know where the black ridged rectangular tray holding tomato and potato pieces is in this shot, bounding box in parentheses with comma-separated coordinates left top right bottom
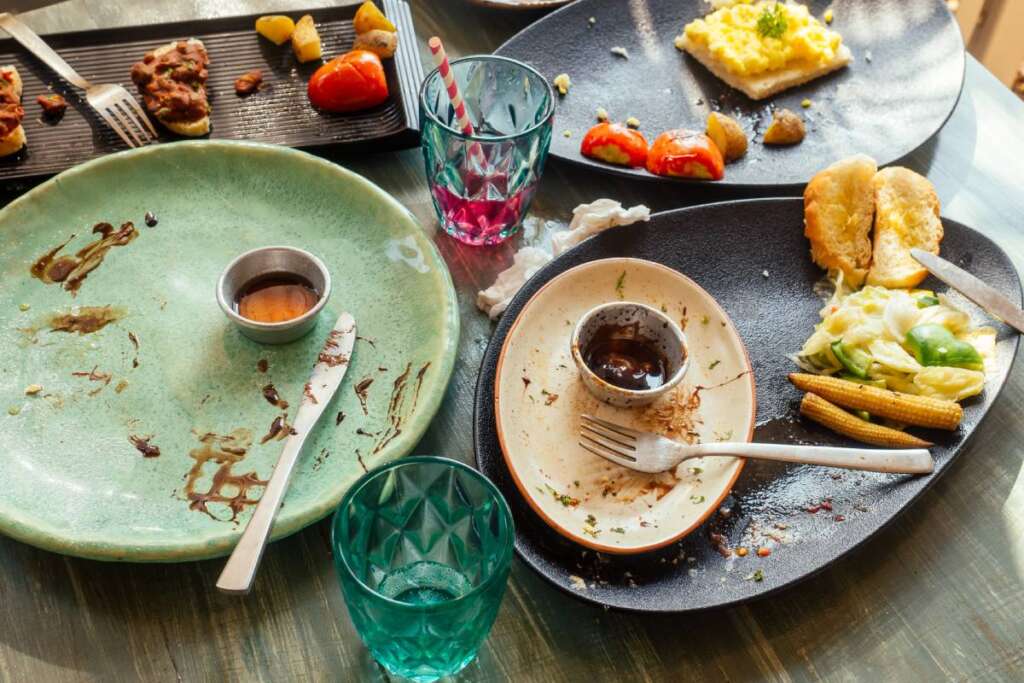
(0, 0, 423, 185)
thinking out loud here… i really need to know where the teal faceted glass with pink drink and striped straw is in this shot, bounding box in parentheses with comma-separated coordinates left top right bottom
(420, 55, 555, 245)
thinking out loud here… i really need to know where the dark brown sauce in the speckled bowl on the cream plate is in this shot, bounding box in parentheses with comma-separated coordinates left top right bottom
(583, 323, 668, 391)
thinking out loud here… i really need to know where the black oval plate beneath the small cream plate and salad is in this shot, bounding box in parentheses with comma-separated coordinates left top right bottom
(474, 199, 1022, 612)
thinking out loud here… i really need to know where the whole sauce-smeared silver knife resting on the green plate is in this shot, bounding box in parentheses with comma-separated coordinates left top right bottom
(217, 313, 355, 595)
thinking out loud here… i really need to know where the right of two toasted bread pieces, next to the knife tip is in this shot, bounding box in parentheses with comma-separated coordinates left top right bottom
(867, 171, 942, 289)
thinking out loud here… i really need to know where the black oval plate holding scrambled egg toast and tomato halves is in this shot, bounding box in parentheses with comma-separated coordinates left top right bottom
(497, 0, 966, 187)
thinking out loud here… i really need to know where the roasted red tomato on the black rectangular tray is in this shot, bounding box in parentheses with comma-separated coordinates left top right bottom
(307, 50, 387, 112)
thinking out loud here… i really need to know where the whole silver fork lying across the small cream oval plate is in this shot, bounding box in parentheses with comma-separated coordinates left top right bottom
(580, 415, 935, 474)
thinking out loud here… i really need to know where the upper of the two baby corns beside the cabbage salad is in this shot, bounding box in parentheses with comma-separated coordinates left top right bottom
(790, 373, 964, 429)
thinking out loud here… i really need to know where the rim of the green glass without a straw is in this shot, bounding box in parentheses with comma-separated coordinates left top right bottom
(331, 456, 515, 611)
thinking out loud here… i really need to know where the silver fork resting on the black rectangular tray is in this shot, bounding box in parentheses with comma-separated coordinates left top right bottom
(0, 12, 157, 147)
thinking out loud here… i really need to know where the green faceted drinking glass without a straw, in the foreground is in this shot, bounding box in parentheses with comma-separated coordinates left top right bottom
(332, 456, 515, 681)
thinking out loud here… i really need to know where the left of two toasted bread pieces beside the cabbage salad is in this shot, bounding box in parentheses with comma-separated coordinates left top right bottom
(804, 155, 878, 287)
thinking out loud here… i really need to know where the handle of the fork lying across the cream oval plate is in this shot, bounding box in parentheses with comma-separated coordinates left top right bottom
(686, 442, 935, 474)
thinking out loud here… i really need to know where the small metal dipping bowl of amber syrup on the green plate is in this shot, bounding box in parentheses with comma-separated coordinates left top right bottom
(217, 247, 331, 344)
